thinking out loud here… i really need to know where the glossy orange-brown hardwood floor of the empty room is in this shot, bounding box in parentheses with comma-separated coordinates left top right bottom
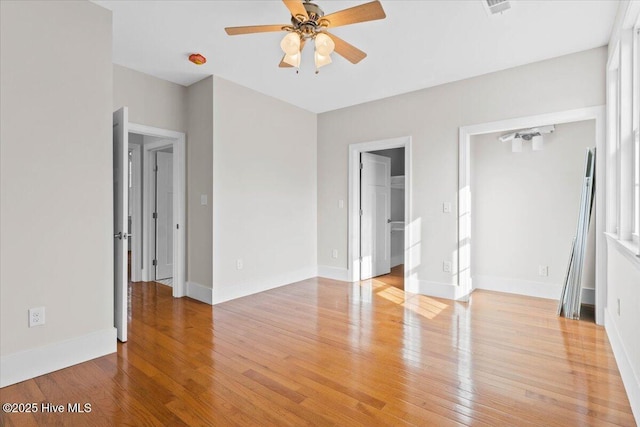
(0, 279, 635, 427)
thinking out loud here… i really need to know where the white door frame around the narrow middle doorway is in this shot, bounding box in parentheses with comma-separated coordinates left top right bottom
(347, 136, 417, 293)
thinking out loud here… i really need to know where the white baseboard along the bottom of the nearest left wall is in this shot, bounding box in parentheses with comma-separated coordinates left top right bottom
(0, 328, 118, 387)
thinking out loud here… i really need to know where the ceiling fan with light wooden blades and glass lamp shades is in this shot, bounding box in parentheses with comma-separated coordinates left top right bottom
(225, 0, 386, 73)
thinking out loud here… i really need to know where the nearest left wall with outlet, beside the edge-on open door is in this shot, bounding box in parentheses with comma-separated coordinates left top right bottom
(0, 1, 116, 386)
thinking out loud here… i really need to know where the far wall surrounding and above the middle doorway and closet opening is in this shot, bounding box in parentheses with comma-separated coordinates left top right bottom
(318, 48, 606, 286)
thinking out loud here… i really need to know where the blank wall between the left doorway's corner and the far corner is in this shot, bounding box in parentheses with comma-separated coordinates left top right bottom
(213, 77, 317, 302)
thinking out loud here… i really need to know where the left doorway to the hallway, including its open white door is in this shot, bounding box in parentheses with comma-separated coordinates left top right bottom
(113, 107, 186, 342)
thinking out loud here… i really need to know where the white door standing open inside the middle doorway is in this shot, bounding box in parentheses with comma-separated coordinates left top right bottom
(360, 153, 391, 280)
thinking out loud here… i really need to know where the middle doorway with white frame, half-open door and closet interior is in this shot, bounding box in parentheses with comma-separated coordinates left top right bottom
(348, 137, 415, 292)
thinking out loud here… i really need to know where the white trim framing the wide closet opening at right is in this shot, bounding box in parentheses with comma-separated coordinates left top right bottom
(457, 106, 607, 325)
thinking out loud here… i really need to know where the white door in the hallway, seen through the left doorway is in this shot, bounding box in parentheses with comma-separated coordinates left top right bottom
(156, 151, 173, 280)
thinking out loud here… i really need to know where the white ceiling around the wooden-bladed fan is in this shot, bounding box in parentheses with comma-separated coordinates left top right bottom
(94, 0, 618, 113)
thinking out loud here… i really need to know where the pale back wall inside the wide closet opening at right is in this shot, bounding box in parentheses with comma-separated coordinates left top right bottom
(470, 120, 595, 304)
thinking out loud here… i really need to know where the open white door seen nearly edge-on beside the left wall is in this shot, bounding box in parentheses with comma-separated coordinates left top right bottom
(113, 107, 129, 342)
